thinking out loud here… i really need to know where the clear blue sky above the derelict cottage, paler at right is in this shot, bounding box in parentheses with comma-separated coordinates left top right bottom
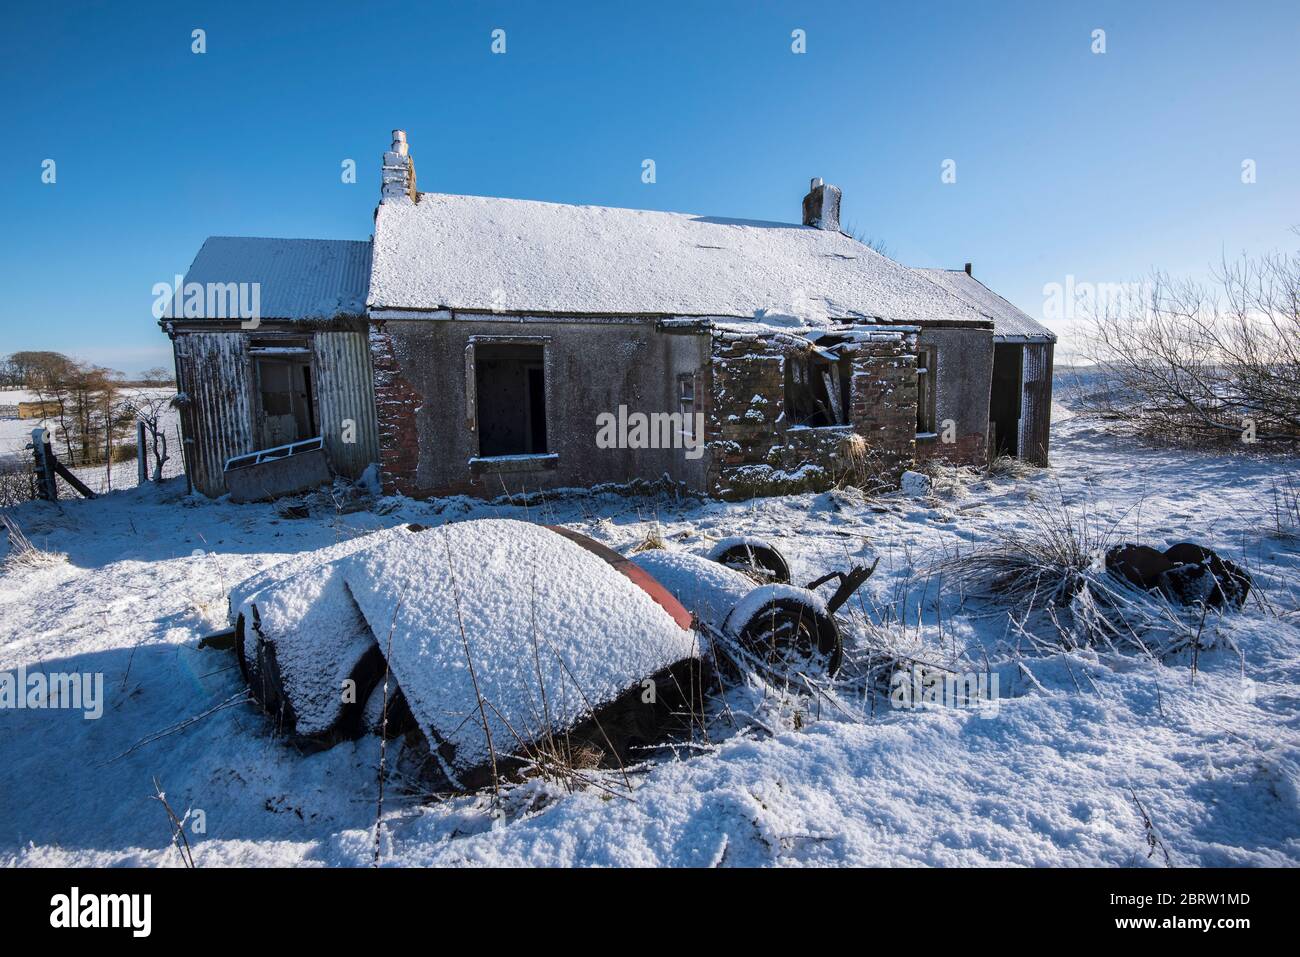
(0, 0, 1300, 372)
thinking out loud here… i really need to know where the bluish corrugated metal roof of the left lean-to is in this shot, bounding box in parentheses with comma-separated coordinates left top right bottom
(185, 235, 371, 320)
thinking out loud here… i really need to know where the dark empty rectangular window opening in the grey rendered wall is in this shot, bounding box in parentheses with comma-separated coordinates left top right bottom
(475, 343, 549, 456)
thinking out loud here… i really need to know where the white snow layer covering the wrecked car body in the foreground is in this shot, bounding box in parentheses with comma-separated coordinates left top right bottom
(231, 519, 696, 770)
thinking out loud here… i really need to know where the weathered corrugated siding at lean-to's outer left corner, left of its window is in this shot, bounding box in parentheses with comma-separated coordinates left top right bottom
(174, 333, 254, 497)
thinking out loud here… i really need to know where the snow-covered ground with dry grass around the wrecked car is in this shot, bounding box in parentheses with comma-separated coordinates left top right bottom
(0, 403, 1300, 866)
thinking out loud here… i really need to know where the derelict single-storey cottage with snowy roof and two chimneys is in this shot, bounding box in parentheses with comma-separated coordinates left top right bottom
(161, 131, 1054, 498)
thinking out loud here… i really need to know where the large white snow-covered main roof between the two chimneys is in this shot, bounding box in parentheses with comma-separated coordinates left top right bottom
(367, 192, 987, 322)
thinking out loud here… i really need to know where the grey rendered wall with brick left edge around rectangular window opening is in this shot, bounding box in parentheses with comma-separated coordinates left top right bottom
(371, 316, 709, 498)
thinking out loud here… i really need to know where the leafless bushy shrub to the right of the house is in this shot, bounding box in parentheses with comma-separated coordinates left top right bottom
(1083, 237, 1300, 447)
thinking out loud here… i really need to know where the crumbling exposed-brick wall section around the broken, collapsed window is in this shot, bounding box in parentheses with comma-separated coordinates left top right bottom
(707, 328, 917, 498)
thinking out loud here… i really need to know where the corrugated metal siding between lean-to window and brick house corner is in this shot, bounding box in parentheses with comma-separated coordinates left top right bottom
(312, 332, 380, 479)
